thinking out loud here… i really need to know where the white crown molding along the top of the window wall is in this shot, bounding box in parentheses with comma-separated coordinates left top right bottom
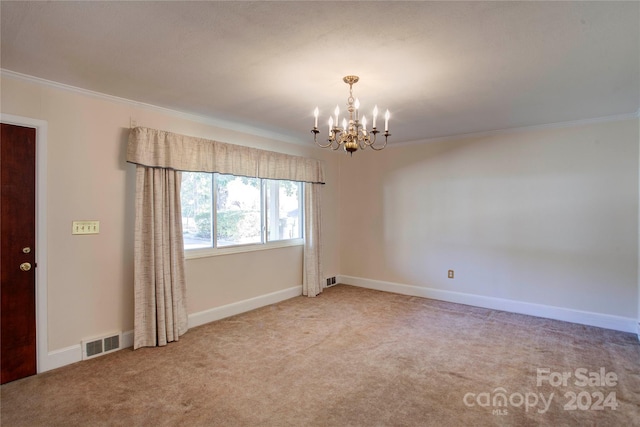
(0, 68, 304, 145)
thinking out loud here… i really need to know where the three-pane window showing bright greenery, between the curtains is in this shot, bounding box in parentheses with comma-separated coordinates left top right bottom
(180, 172, 303, 250)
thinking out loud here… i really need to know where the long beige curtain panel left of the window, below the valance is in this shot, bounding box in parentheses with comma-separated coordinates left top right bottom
(133, 166, 188, 349)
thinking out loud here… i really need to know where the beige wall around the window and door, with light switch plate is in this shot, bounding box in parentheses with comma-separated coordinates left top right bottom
(1, 76, 338, 361)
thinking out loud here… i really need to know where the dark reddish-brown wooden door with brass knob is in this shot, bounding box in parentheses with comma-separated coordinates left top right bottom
(0, 123, 37, 384)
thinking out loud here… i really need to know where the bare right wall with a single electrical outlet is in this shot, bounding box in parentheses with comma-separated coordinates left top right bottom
(340, 119, 639, 325)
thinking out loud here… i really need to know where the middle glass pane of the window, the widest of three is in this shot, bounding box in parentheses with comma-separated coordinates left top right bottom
(216, 175, 262, 247)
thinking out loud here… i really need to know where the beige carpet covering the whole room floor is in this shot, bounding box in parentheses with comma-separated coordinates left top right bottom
(1, 285, 640, 427)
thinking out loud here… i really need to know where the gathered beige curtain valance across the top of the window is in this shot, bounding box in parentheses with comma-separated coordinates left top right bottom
(127, 127, 324, 184)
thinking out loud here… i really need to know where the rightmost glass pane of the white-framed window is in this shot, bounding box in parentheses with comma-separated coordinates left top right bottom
(266, 181, 302, 241)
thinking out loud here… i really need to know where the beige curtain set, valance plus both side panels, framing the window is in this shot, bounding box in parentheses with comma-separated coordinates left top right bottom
(127, 127, 324, 349)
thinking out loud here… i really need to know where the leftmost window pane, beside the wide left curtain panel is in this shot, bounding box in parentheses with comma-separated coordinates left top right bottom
(180, 172, 213, 249)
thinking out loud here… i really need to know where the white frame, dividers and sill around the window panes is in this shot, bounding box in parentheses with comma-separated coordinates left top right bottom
(180, 172, 305, 259)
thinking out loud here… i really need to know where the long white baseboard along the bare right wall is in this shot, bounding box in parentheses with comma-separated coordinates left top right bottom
(338, 276, 638, 334)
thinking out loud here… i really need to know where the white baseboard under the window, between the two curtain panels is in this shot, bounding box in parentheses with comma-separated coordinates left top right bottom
(189, 285, 302, 328)
